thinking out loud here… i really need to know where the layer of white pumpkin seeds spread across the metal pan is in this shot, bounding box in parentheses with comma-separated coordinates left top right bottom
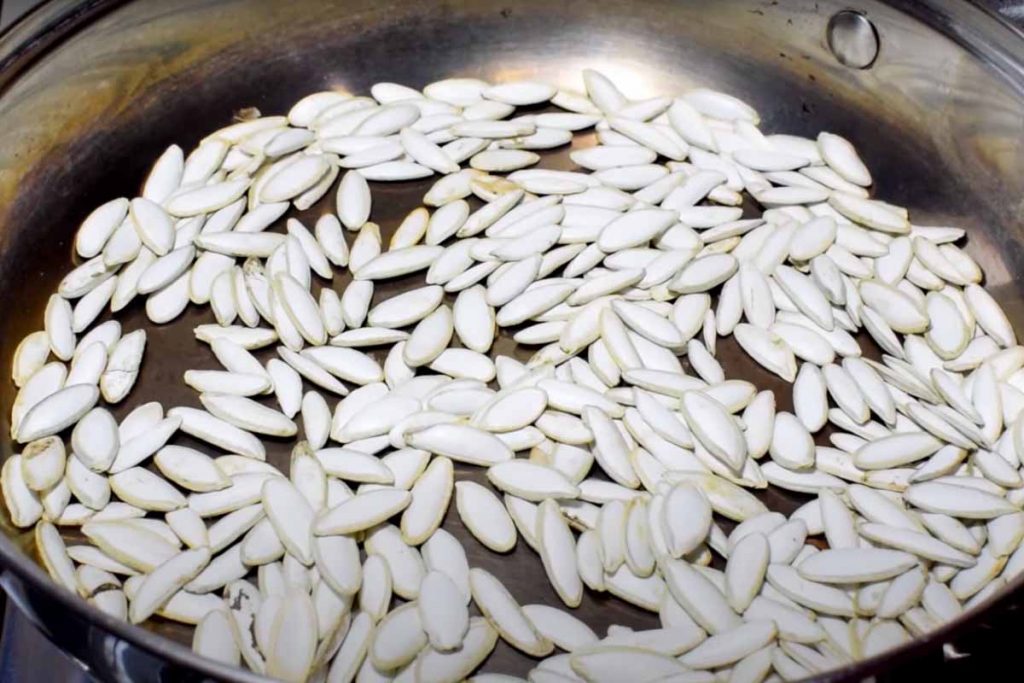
(3, 72, 1024, 683)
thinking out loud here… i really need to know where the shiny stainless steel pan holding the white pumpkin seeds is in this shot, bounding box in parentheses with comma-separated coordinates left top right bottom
(0, 0, 1024, 681)
